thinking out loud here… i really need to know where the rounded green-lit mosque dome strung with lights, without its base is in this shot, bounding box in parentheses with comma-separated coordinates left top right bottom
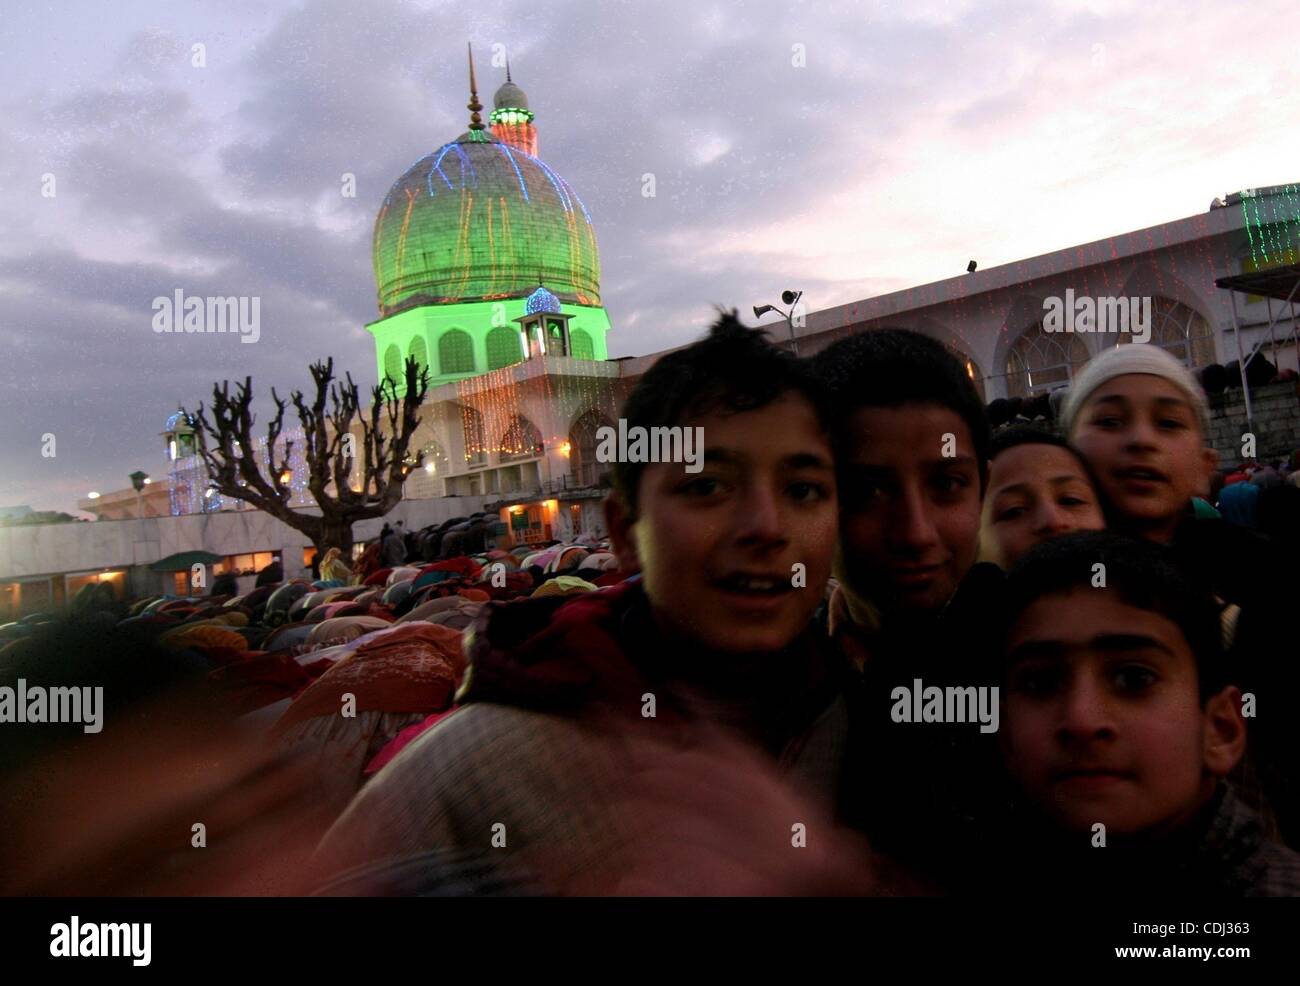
(373, 129, 601, 316)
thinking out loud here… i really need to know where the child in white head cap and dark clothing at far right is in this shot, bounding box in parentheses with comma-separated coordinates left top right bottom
(1062, 343, 1300, 846)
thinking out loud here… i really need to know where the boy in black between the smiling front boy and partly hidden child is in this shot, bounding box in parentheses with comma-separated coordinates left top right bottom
(815, 329, 1001, 890)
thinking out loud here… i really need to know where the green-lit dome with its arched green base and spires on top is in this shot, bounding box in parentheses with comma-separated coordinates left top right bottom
(367, 61, 610, 386)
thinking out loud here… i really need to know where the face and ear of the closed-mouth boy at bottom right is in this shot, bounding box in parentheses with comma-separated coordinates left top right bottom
(1002, 587, 1244, 835)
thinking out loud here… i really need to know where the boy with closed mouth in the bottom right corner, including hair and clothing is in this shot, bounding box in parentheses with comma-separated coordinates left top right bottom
(998, 533, 1300, 900)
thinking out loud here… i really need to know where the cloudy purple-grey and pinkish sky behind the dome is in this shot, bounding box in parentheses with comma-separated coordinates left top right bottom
(0, 0, 1300, 511)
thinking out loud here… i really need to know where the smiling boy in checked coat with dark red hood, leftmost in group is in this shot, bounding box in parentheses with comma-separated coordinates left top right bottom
(310, 315, 846, 894)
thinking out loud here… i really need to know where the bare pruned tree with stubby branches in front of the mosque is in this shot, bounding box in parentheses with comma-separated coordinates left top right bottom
(185, 356, 429, 557)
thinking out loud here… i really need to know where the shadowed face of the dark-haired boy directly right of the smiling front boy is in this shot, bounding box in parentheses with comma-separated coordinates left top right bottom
(840, 403, 980, 615)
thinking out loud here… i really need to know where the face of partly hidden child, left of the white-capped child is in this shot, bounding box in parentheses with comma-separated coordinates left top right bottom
(982, 445, 1106, 568)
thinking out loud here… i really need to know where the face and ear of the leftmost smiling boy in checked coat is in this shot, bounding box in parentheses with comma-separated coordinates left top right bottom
(606, 394, 837, 653)
